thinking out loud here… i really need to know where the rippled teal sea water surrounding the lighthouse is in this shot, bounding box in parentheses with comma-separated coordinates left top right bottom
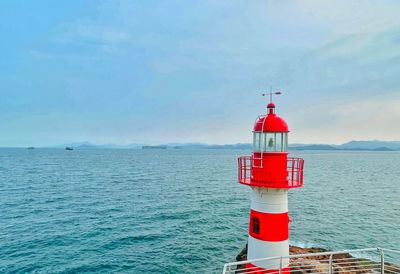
(0, 149, 400, 273)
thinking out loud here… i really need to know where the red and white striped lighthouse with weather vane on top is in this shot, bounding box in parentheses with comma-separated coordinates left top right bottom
(238, 92, 304, 273)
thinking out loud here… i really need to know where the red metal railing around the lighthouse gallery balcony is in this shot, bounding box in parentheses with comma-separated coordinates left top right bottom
(238, 156, 304, 188)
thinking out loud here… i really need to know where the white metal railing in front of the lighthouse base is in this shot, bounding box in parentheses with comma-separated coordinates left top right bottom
(222, 248, 400, 274)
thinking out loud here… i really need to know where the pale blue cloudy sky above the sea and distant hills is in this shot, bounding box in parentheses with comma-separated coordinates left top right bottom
(0, 0, 400, 146)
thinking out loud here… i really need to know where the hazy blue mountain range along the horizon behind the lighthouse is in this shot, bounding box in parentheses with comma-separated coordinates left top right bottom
(33, 140, 400, 151)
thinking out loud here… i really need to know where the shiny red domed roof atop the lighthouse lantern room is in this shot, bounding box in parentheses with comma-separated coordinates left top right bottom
(254, 102, 289, 132)
